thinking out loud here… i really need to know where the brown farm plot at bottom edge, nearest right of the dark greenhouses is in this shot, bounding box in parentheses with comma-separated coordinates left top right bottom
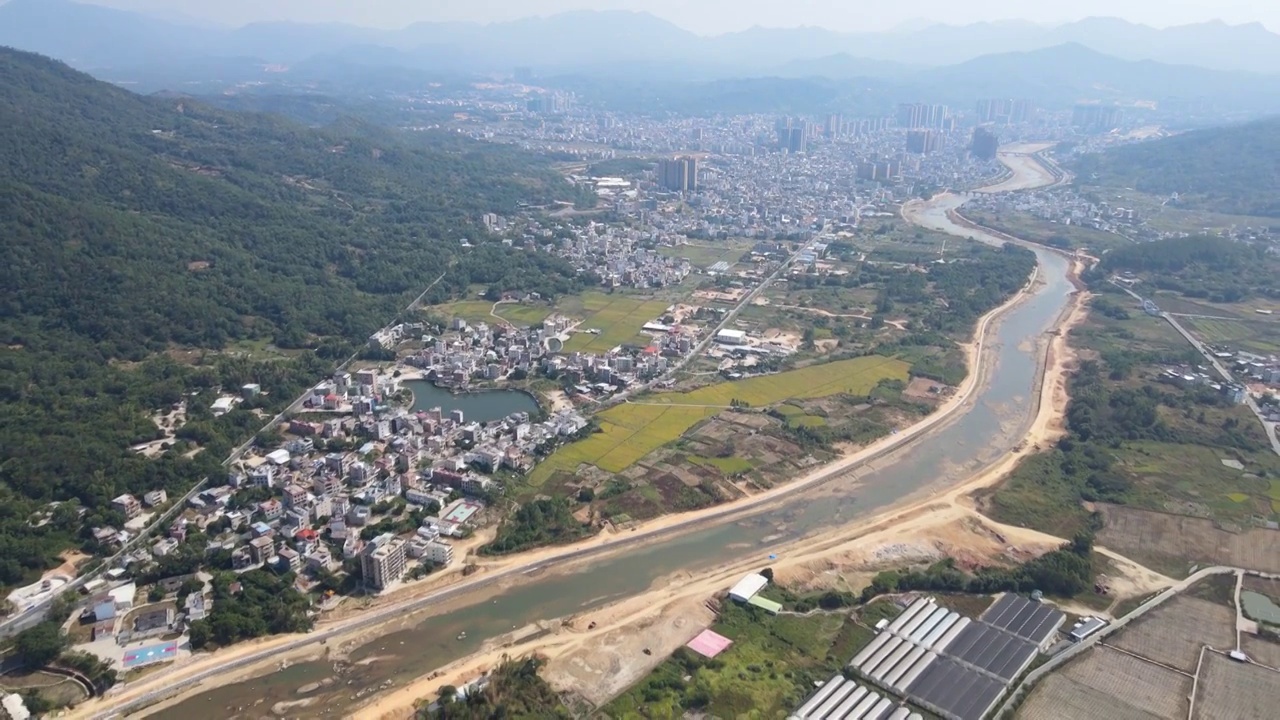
(1039, 647, 1192, 717)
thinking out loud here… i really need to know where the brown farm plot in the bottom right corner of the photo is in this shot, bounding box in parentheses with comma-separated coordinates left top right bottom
(1192, 652, 1280, 720)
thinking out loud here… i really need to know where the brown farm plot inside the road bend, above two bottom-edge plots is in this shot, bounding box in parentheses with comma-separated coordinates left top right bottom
(1110, 596, 1235, 673)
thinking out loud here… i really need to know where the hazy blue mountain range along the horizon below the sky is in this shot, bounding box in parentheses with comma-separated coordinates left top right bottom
(0, 0, 1280, 79)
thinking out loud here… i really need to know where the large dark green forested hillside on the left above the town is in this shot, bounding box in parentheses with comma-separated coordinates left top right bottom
(0, 49, 579, 587)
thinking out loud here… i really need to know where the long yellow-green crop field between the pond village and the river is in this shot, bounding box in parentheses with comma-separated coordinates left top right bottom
(529, 355, 910, 486)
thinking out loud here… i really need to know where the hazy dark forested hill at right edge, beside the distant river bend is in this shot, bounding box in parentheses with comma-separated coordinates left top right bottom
(1075, 118, 1280, 218)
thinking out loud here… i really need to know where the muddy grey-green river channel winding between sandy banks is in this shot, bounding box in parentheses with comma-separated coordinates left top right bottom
(151, 166, 1073, 720)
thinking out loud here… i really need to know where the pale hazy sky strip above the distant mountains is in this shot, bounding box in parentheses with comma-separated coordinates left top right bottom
(74, 0, 1280, 35)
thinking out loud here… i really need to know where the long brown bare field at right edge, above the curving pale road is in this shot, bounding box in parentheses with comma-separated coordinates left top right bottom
(1097, 502, 1280, 573)
